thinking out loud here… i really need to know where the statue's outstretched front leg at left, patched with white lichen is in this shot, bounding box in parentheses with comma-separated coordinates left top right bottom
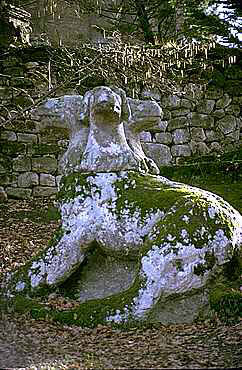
(3, 229, 91, 295)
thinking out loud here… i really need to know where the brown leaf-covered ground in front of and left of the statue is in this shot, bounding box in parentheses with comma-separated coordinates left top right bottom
(0, 200, 242, 369)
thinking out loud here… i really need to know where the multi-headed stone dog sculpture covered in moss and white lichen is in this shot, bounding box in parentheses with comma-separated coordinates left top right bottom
(2, 87, 242, 324)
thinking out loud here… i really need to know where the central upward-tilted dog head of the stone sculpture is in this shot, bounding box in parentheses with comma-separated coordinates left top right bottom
(81, 86, 131, 124)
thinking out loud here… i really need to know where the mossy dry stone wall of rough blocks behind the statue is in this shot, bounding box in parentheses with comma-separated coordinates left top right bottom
(0, 50, 242, 200)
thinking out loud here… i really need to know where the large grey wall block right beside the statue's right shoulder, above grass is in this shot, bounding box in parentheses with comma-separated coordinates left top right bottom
(142, 143, 172, 167)
